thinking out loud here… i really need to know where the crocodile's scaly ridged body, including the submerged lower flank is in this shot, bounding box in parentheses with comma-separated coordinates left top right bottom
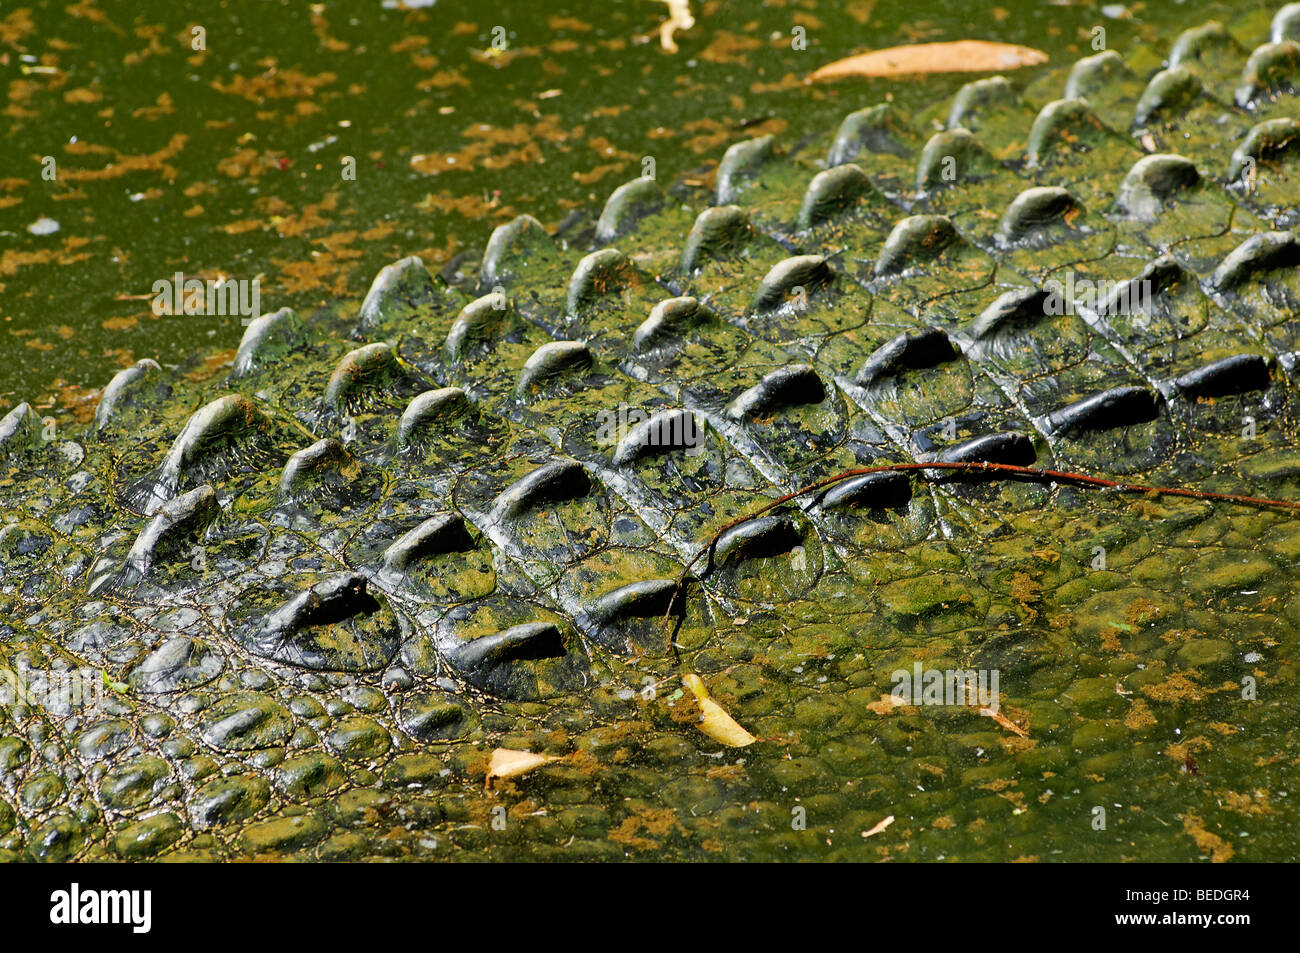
(0, 4, 1300, 861)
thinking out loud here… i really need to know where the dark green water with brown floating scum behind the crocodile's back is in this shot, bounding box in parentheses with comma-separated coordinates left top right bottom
(0, 0, 1218, 419)
